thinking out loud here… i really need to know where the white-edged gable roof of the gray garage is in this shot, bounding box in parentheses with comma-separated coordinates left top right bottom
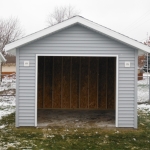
(4, 16, 150, 53)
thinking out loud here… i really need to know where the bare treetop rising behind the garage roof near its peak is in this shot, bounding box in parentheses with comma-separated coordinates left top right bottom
(47, 5, 80, 26)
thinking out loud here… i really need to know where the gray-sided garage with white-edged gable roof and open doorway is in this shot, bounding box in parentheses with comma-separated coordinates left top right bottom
(5, 16, 150, 128)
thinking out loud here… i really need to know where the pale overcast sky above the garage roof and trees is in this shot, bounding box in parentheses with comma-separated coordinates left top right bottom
(0, 0, 150, 42)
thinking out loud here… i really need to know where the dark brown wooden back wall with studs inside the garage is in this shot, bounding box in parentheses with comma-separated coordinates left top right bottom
(38, 56, 116, 109)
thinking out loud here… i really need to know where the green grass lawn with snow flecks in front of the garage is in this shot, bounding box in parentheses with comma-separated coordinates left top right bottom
(0, 111, 150, 150)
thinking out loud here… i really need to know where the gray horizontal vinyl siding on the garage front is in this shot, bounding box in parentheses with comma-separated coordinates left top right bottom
(17, 24, 137, 127)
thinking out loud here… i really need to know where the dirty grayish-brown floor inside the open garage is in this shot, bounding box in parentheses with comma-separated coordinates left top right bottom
(38, 109, 115, 128)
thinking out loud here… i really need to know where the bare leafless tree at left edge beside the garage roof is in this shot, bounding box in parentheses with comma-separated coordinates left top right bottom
(0, 17, 23, 53)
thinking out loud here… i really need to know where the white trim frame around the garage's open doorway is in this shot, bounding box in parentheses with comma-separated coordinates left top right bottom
(35, 54, 118, 127)
